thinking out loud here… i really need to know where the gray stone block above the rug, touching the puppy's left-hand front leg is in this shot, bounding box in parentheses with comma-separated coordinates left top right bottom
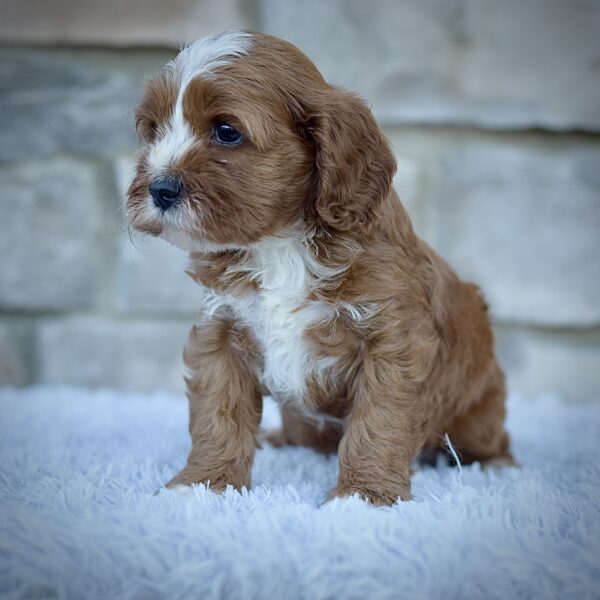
(36, 317, 192, 391)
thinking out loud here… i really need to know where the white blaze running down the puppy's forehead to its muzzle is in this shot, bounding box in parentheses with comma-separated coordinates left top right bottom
(147, 31, 252, 176)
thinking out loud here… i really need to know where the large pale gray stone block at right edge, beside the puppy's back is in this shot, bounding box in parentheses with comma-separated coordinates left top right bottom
(426, 142, 600, 326)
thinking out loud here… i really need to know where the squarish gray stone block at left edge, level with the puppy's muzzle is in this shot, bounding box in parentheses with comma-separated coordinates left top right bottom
(0, 160, 108, 310)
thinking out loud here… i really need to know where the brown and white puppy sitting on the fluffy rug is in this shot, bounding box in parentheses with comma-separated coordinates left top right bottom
(127, 31, 512, 504)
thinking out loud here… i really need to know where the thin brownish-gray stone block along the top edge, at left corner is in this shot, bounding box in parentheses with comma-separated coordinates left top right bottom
(0, 0, 257, 48)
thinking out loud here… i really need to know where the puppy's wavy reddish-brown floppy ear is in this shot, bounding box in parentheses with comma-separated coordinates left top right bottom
(304, 87, 396, 231)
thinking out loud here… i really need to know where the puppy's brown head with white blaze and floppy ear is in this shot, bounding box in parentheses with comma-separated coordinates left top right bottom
(127, 32, 395, 251)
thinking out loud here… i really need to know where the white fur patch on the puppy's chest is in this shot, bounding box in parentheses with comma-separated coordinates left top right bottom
(208, 238, 335, 403)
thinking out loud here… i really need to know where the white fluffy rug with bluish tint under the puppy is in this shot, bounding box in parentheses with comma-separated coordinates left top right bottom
(0, 388, 600, 600)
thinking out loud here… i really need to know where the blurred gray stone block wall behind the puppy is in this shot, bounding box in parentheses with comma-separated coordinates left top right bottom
(0, 0, 600, 400)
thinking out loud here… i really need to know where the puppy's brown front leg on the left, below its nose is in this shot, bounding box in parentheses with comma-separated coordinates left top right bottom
(167, 315, 262, 490)
